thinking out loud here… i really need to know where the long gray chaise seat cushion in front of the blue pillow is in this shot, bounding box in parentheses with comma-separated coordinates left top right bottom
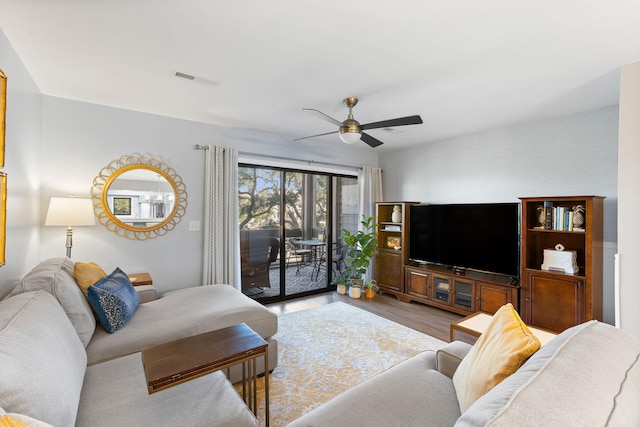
(87, 285, 278, 364)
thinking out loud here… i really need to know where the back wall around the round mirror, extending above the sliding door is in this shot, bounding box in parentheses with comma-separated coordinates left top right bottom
(39, 96, 377, 292)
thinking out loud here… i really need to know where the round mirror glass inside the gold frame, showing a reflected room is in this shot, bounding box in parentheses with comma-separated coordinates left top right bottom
(107, 169, 176, 228)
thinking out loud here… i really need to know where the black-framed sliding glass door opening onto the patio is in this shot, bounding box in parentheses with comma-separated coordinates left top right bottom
(238, 165, 358, 301)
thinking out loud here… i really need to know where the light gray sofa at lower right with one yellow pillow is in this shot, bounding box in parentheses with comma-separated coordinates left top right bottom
(289, 321, 640, 427)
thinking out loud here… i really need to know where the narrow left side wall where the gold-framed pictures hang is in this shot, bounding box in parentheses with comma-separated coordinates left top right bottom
(0, 30, 42, 298)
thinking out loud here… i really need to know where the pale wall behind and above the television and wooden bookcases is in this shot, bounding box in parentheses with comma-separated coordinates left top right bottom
(380, 106, 620, 323)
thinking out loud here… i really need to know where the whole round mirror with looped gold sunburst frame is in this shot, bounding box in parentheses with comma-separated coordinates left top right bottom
(91, 155, 187, 240)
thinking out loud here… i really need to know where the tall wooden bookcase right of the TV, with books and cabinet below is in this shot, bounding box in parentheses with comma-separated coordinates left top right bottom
(520, 196, 604, 332)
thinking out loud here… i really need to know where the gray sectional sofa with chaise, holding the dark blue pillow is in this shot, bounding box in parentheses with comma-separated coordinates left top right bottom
(0, 258, 278, 427)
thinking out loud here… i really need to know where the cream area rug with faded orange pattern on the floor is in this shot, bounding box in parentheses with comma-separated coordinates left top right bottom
(240, 302, 445, 426)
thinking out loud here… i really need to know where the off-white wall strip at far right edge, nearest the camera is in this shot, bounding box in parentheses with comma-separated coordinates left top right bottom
(617, 62, 640, 339)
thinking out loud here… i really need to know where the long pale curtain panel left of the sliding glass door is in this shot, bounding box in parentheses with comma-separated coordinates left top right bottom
(202, 145, 241, 289)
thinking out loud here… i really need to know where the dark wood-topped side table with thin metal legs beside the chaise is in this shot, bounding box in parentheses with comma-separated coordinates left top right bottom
(142, 323, 269, 426)
